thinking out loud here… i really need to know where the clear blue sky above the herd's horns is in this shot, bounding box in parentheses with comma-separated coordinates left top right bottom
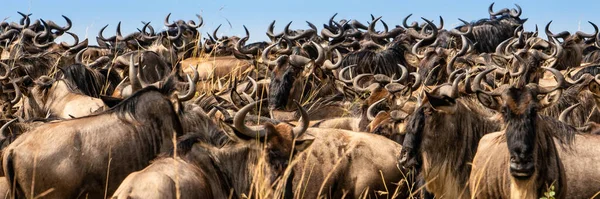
(0, 0, 600, 44)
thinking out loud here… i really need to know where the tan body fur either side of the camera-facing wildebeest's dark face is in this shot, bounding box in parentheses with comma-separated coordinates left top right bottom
(469, 132, 600, 198)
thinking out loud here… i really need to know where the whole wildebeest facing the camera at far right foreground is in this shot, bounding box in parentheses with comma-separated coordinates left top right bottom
(469, 68, 600, 198)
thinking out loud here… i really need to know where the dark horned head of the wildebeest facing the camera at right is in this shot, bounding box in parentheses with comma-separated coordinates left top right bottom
(473, 68, 572, 179)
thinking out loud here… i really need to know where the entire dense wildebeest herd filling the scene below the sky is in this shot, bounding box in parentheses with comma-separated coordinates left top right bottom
(0, 3, 600, 198)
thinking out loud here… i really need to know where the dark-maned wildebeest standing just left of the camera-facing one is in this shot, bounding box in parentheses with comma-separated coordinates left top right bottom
(400, 70, 502, 198)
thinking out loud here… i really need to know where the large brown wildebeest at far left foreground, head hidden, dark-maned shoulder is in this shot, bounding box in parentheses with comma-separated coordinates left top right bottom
(3, 87, 183, 198)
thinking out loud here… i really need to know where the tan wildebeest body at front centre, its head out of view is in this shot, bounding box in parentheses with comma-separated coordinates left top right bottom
(293, 128, 406, 198)
